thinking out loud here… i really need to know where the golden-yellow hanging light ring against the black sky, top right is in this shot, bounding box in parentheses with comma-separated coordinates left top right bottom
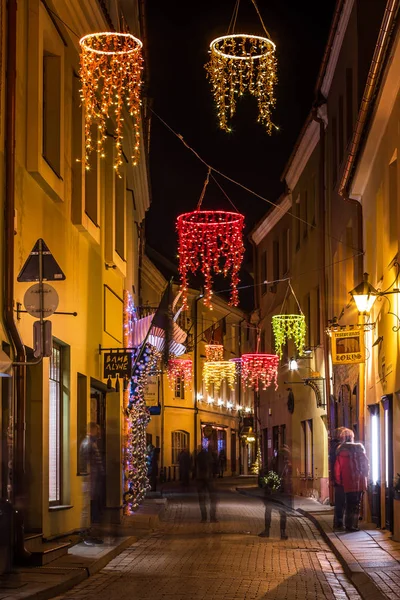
(205, 33, 277, 134)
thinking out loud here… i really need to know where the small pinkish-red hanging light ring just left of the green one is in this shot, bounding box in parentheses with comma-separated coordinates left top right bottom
(241, 354, 279, 392)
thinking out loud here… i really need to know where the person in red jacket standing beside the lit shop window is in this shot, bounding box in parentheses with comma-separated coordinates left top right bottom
(334, 429, 369, 531)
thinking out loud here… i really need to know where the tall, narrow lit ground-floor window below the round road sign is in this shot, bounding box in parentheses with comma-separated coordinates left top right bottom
(49, 342, 63, 505)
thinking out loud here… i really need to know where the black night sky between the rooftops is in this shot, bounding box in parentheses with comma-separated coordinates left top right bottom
(146, 0, 335, 308)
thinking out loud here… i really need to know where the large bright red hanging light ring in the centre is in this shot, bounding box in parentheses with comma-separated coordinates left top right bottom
(177, 210, 244, 310)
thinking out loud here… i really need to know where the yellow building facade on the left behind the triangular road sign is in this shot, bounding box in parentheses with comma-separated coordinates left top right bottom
(1, 0, 149, 539)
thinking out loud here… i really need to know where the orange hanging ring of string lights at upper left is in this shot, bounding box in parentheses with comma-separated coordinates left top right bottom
(79, 31, 143, 173)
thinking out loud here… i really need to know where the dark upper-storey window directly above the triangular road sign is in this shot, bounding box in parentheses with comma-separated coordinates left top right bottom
(42, 50, 61, 177)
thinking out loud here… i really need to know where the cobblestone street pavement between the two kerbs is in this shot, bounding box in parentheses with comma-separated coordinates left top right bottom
(53, 487, 360, 600)
